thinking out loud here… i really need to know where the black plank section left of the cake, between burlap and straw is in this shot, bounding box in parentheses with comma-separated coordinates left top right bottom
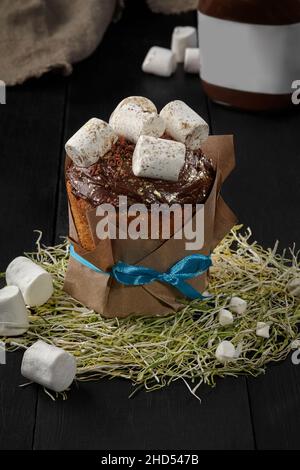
(0, 77, 66, 269)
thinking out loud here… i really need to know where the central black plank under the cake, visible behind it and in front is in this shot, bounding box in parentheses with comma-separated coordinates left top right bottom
(40, 3, 254, 449)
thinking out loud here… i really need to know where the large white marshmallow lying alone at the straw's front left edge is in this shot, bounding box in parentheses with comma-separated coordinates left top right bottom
(21, 340, 76, 392)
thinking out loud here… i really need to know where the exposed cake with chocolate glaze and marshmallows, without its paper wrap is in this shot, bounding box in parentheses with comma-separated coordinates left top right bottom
(66, 96, 215, 250)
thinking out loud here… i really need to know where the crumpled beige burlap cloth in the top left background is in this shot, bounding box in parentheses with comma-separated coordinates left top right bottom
(0, 0, 197, 85)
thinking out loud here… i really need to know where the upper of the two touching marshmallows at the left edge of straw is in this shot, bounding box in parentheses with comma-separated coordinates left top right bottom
(6, 256, 53, 307)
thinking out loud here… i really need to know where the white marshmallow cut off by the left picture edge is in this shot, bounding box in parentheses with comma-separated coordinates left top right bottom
(0, 286, 29, 336)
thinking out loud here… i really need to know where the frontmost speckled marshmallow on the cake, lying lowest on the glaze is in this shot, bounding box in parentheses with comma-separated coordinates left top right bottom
(132, 135, 185, 181)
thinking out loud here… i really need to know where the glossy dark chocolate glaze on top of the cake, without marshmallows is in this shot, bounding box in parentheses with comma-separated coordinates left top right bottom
(66, 136, 215, 207)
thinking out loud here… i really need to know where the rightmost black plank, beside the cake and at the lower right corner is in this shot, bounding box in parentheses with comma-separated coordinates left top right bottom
(209, 98, 300, 449)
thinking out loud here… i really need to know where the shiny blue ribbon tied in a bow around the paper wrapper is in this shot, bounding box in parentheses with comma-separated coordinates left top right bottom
(70, 245, 212, 299)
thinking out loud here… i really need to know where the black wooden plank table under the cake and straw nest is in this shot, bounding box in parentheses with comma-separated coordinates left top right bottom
(0, 2, 300, 449)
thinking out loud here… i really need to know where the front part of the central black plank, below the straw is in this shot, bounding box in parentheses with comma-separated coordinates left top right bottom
(35, 378, 253, 450)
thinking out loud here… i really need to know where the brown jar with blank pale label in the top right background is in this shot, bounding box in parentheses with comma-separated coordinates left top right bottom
(198, 0, 300, 111)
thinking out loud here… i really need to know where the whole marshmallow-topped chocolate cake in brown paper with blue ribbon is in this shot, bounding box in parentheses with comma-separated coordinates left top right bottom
(64, 96, 236, 318)
